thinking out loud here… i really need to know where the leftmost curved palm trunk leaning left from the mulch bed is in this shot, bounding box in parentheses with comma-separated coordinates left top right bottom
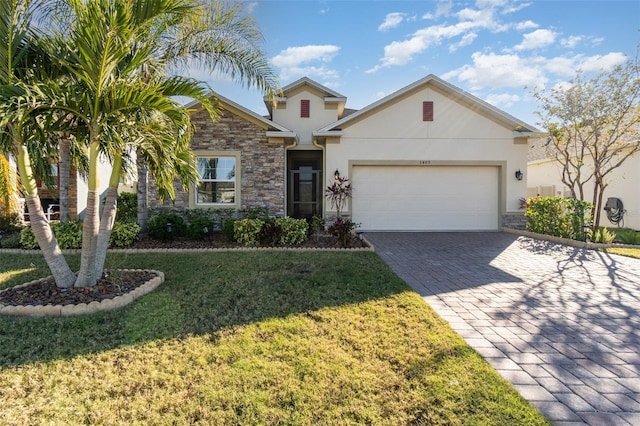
(14, 142, 76, 288)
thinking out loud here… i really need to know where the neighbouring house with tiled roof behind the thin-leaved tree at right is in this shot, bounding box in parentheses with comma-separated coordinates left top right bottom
(527, 136, 640, 230)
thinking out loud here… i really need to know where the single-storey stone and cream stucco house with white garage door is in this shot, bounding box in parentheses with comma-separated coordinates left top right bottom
(149, 75, 540, 231)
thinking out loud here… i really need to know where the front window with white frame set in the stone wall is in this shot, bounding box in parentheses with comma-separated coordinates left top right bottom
(196, 157, 236, 204)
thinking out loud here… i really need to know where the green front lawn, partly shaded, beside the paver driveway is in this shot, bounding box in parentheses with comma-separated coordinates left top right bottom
(0, 252, 548, 425)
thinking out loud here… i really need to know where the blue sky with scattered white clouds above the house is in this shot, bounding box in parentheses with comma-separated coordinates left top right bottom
(192, 0, 640, 129)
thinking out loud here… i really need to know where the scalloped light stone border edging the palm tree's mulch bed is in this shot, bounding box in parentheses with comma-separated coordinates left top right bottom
(0, 269, 164, 317)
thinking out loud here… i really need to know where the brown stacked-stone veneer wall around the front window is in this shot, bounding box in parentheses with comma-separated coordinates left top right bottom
(148, 106, 285, 216)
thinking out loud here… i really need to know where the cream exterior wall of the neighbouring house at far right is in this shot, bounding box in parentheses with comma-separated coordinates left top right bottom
(527, 154, 640, 230)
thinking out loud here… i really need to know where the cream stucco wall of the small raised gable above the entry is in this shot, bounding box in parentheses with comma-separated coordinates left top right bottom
(273, 86, 338, 149)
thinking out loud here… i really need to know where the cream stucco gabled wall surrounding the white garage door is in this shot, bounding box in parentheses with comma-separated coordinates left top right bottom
(326, 88, 528, 213)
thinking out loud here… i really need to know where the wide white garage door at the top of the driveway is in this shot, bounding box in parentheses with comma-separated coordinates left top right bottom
(351, 166, 499, 231)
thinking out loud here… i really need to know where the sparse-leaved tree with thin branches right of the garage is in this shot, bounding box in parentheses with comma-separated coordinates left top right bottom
(534, 59, 640, 228)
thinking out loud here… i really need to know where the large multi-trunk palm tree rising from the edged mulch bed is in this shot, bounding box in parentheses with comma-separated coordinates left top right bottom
(0, 0, 277, 287)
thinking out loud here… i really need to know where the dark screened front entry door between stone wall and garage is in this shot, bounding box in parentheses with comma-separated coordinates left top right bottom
(287, 151, 322, 219)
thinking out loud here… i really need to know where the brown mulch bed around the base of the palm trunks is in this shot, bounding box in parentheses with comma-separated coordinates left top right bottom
(0, 271, 156, 306)
